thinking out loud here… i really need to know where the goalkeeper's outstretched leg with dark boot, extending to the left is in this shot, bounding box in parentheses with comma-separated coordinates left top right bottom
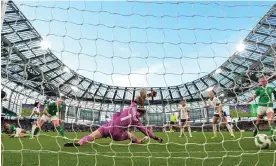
(64, 128, 102, 147)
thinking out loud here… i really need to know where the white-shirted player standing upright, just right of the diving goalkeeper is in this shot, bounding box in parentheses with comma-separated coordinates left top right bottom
(178, 99, 192, 137)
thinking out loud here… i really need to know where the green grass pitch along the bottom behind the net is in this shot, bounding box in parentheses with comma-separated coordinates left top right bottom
(1, 132, 276, 166)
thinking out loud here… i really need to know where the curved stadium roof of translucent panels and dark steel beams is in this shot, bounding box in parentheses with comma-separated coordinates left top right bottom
(1, 1, 276, 104)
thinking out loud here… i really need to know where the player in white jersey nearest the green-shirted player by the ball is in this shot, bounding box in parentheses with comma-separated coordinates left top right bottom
(206, 91, 235, 139)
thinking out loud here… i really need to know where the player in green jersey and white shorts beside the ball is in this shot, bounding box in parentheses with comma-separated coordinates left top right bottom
(247, 77, 276, 137)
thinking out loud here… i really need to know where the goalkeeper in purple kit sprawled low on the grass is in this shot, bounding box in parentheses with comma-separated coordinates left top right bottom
(64, 89, 163, 147)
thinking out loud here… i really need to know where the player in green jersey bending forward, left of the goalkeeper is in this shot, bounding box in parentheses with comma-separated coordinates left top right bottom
(35, 99, 64, 137)
